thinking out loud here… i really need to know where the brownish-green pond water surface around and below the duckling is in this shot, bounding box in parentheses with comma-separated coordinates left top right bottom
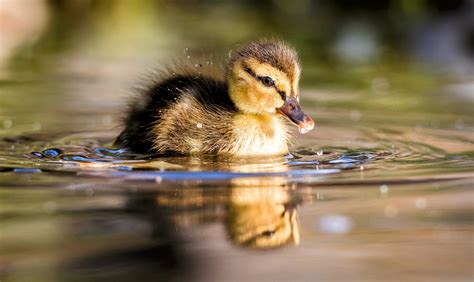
(0, 2, 474, 281)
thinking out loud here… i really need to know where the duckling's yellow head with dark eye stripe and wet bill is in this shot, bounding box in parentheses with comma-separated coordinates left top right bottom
(227, 41, 314, 131)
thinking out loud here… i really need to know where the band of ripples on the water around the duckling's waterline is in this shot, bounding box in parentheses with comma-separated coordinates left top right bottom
(0, 126, 474, 184)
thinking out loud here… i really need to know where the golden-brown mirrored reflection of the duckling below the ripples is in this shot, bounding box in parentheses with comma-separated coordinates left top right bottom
(156, 186, 300, 249)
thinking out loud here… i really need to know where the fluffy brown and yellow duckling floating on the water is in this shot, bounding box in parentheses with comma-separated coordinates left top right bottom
(115, 41, 314, 156)
